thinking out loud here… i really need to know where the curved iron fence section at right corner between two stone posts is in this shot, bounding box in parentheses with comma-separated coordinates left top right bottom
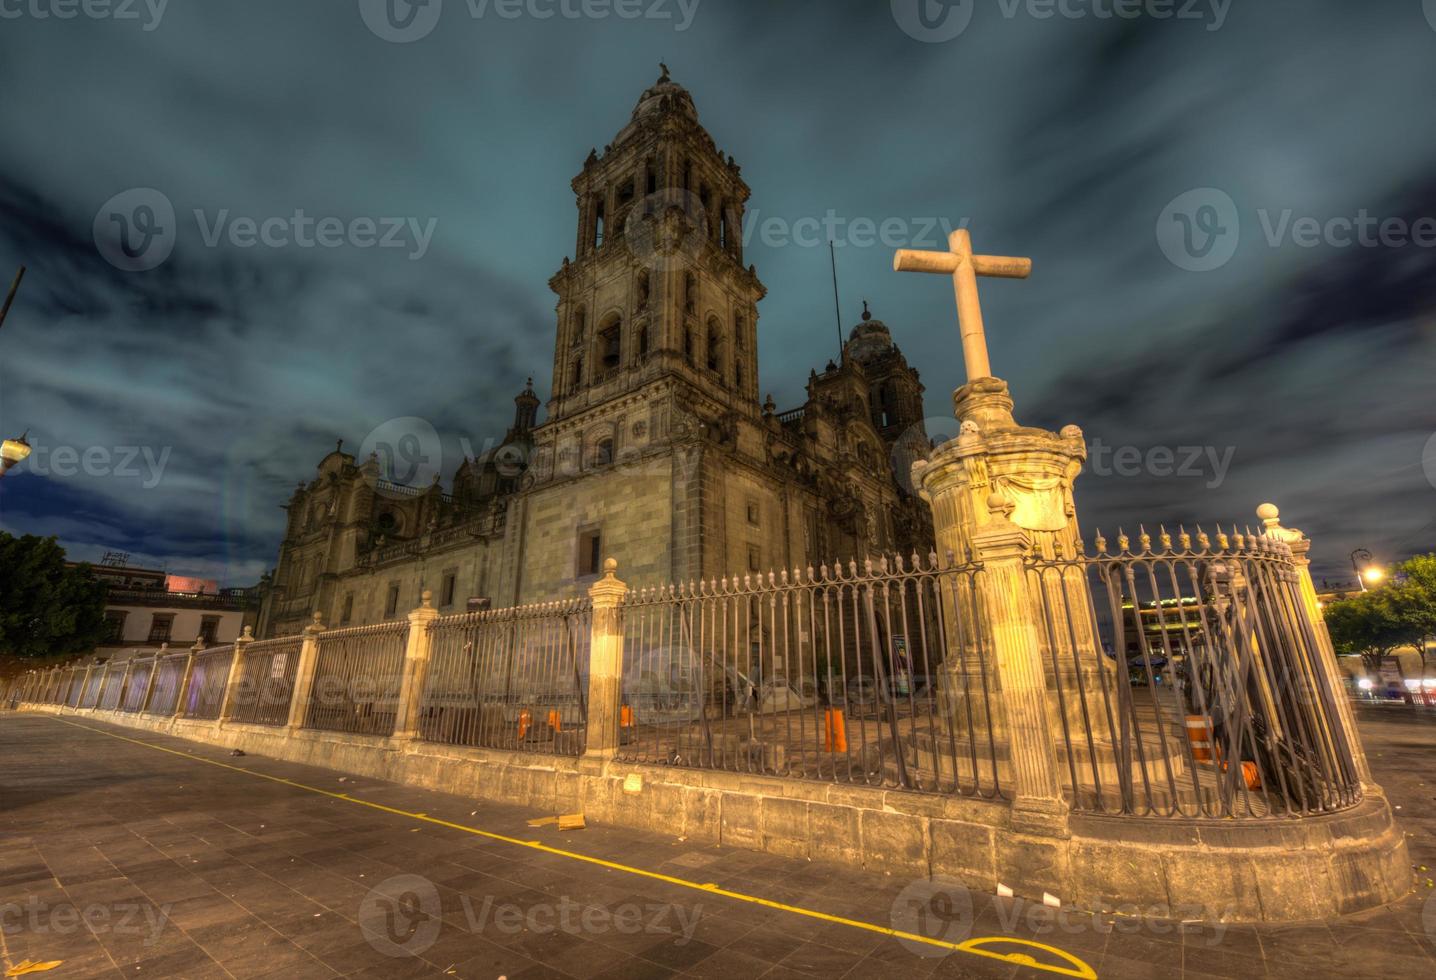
(1028, 530, 1360, 819)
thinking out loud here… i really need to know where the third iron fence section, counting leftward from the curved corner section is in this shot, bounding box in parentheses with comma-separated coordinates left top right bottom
(418, 599, 593, 756)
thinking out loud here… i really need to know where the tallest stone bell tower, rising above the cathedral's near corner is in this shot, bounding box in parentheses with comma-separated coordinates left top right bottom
(549, 66, 765, 420)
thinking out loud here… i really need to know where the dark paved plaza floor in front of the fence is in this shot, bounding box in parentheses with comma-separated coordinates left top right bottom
(0, 708, 1436, 980)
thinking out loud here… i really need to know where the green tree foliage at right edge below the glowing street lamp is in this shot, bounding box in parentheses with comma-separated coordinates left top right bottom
(1325, 555, 1436, 670)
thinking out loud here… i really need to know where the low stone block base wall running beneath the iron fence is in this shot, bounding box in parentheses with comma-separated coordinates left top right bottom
(23, 706, 1412, 923)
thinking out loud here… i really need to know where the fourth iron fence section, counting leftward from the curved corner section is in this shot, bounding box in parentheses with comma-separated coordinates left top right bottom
(304, 621, 409, 736)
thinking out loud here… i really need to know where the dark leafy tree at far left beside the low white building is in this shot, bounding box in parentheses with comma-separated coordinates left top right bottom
(0, 532, 105, 658)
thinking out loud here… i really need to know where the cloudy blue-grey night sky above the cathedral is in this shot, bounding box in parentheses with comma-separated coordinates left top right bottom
(0, 0, 1436, 585)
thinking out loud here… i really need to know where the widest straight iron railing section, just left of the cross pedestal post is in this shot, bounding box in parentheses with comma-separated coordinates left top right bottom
(616, 555, 1004, 798)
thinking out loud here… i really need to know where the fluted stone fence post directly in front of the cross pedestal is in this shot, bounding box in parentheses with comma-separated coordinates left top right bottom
(971, 493, 1068, 836)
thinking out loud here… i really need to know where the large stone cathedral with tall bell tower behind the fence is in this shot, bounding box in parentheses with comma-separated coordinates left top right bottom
(258, 68, 932, 637)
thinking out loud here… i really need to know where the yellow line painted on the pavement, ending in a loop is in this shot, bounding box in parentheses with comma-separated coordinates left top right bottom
(50, 716, 1097, 980)
